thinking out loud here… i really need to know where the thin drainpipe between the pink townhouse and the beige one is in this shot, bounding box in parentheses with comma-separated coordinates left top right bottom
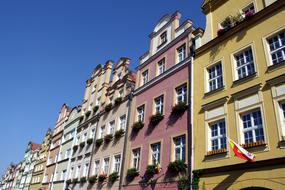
(119, 80, 134, 190)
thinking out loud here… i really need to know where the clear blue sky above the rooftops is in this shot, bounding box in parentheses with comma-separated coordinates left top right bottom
(0, 0, 205, 175)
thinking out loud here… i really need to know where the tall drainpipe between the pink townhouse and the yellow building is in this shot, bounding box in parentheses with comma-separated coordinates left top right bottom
(187, 40, 195, 190)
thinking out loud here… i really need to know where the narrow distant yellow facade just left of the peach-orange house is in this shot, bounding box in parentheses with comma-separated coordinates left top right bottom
(30, 129, 52, 190)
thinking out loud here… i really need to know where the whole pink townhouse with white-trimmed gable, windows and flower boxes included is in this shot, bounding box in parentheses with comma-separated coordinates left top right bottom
(123, 12, 195, 189)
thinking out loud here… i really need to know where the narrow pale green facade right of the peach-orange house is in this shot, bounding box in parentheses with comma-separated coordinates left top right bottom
(52, 106, 81, 190)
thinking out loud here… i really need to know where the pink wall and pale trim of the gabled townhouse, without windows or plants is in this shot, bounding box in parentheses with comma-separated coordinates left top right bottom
(123, 13, 192, 190)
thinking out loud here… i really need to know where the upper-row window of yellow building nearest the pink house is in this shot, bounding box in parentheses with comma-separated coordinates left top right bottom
(208, 63, 223, 91)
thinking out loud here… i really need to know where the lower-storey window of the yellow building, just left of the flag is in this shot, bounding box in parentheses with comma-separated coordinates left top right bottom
(210, 120, 224, 150)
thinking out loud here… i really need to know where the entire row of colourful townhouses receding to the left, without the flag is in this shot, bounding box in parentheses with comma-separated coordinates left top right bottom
(0, 0, 285, 190)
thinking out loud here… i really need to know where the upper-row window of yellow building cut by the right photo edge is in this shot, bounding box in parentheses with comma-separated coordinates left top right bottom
(267, 31, 285, 65)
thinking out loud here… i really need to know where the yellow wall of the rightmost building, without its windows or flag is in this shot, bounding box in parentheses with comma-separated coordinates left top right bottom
(193, 0, 285, 189)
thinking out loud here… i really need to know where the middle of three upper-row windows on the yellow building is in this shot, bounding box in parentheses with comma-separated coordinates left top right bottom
(234, 48, 255, 79)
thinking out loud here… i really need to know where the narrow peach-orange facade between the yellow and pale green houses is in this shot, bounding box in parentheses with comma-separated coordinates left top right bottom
(41, 104, 71, 190)
